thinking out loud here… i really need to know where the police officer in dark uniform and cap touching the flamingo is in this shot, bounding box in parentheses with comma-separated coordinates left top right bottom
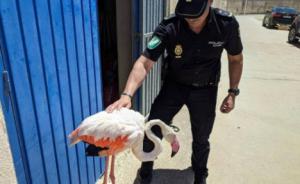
(107, 0, 243, 184)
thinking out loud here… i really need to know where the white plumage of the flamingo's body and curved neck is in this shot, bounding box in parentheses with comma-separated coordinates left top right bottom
(69, 108, 175, 161)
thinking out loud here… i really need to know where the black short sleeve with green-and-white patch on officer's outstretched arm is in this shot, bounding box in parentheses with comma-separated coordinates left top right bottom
(142, 22, 168, 61)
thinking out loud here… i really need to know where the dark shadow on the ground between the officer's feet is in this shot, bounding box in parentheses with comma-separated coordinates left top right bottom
(133, 167, 194, 184)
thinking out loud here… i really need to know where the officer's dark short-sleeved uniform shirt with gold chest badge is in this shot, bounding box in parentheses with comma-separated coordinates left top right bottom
(143, 8, 243, 84)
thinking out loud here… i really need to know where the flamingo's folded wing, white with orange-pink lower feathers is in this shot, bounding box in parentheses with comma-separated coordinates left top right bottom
(69, 109, 144, 147)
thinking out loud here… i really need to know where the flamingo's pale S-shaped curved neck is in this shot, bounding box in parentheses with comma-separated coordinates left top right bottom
(133, 120, 168, 162)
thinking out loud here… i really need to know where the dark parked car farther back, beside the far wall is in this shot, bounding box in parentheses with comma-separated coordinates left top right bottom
(262, 6, 298, 28)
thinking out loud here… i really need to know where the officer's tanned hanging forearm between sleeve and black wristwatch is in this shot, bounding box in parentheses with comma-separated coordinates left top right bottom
(228, 53, 243, 88)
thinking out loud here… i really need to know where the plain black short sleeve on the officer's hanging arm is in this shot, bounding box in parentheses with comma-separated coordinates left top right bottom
(225, 18, 243, 55)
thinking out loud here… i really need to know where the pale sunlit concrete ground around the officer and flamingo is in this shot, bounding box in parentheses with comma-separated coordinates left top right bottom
(98, 15, 300, 184)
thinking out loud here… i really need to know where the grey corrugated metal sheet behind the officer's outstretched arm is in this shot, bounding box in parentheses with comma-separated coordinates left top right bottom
(140, 0, 165, 114)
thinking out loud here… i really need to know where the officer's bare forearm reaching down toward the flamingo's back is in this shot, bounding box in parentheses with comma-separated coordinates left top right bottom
(124, 55, 155, 96)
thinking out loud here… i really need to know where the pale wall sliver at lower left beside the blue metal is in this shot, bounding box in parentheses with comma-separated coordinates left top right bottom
(0, 106, 17, 184)
